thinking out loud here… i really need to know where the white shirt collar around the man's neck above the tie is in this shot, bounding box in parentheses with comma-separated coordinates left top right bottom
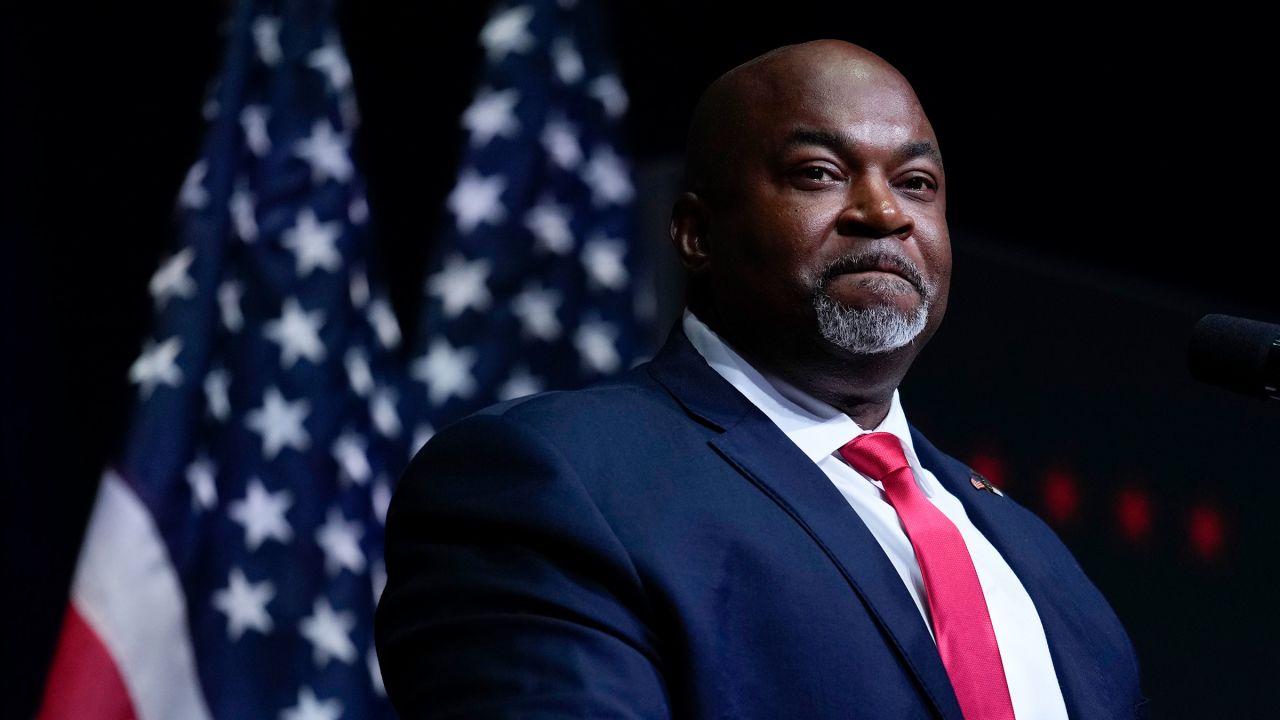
(682, 309, 919, 466)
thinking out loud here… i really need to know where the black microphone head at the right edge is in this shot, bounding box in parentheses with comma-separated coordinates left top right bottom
(1187, 315, 1280, 400)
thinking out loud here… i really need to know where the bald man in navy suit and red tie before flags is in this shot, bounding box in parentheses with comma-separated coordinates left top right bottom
(378, 41, 1143, 720)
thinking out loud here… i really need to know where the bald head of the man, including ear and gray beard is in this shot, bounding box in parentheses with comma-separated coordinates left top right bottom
(672, 40, 951, 399)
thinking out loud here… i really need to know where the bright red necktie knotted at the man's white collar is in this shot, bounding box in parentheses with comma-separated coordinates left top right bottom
(840, 433, 1014, 720)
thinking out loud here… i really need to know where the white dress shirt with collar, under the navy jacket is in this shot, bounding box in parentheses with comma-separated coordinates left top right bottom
(684, 310, 1066, 720)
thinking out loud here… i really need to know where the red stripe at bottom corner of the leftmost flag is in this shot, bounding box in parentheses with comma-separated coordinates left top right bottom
(36, 605, 138, 720)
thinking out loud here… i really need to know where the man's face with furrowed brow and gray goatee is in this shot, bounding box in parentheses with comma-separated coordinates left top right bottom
(708, 52, 951, 355)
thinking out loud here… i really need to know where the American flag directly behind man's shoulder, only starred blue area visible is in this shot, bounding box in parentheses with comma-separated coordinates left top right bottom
(410, 0, 652, 427)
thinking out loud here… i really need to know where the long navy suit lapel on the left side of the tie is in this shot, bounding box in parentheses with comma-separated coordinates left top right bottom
(650, 327, 961, 720)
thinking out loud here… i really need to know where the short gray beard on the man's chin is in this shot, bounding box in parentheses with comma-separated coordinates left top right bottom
(813, 292, 931, 355)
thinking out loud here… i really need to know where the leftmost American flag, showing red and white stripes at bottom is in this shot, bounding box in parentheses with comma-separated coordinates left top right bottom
(41, 0, 409, 720)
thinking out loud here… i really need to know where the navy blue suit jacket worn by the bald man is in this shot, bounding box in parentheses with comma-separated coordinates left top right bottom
(376, 328, 1143, 720)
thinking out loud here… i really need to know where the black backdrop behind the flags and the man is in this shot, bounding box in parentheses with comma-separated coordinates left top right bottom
(0, 0, 1280, 717)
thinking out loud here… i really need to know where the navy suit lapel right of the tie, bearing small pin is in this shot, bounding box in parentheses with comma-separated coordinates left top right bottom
(911, 428, 1106, 717)
